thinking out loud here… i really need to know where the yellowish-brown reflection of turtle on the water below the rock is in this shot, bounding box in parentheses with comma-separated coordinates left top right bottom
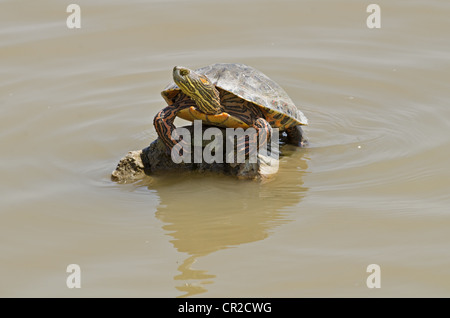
(152, 146, 307, 297)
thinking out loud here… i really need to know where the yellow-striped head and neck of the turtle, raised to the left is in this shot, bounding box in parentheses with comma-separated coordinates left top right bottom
(173, 66, 222, 114)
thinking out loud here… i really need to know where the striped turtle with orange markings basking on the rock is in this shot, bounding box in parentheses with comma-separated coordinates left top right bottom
(153, 63, 308, 154)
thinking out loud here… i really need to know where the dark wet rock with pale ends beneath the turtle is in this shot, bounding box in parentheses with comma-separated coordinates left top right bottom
(111, 126, 278, 183)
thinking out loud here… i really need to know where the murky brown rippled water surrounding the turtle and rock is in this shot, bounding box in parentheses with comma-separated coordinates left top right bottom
(0, 0, 450, 297)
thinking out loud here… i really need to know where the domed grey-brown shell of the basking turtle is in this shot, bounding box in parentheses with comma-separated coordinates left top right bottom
(161, 63, 308, 125)
